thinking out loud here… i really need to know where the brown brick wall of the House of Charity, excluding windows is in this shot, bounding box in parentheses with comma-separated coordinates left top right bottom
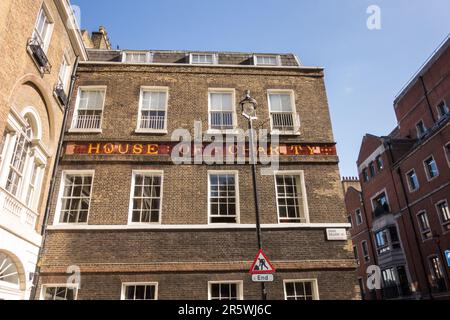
(36, 56, 357, 299)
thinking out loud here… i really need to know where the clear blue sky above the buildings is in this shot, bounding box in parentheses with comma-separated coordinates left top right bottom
(71, 0, 450, 176)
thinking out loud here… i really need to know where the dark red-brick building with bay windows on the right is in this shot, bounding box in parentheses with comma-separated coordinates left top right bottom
(345, 38, 450, 299)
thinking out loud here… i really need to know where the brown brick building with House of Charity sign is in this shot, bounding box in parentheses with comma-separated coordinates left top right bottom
(36, 30, 359, 299)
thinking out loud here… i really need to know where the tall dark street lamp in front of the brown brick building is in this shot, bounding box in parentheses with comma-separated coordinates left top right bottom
(240, 90, 267, 300)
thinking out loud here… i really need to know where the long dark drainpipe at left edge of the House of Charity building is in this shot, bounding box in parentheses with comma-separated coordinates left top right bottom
(30, 56, 80, 300)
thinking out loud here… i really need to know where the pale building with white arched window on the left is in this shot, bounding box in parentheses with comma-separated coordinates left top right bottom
(0, 0, 87, 300)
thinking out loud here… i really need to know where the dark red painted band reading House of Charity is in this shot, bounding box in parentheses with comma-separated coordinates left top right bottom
(65, 142, 336, 156)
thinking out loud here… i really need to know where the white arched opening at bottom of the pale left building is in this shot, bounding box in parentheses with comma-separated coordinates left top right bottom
(0, 251, 25, 300)
